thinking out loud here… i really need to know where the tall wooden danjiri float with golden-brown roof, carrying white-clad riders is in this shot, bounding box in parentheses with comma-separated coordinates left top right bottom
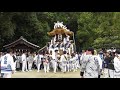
(47, 21, 75, 55)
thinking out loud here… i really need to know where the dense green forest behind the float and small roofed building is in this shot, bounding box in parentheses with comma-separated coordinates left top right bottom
(0, 12, 120, 51)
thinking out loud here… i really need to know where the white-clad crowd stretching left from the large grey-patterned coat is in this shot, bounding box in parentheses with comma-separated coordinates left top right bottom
(0, 47, 80, 77)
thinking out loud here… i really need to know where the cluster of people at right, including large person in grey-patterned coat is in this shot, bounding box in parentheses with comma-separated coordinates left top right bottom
(80, 48, 120, 78)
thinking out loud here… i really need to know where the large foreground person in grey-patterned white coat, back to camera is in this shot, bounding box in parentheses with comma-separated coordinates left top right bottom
(80, 48, 100, 78)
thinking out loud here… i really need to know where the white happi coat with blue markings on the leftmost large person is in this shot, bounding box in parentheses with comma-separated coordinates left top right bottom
(1, 54, 15, 73)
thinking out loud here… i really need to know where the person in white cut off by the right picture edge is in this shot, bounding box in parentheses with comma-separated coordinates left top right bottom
(114, 50, 120, 78)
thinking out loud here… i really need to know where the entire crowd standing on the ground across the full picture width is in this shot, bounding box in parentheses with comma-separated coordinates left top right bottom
(0, 48, 120, 78)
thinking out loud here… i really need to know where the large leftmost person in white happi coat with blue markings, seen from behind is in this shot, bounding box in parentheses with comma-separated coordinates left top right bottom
(1, 50, 15, 78)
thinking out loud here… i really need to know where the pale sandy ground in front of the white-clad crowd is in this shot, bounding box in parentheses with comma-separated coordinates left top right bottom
(12, 70, 103, 78)
